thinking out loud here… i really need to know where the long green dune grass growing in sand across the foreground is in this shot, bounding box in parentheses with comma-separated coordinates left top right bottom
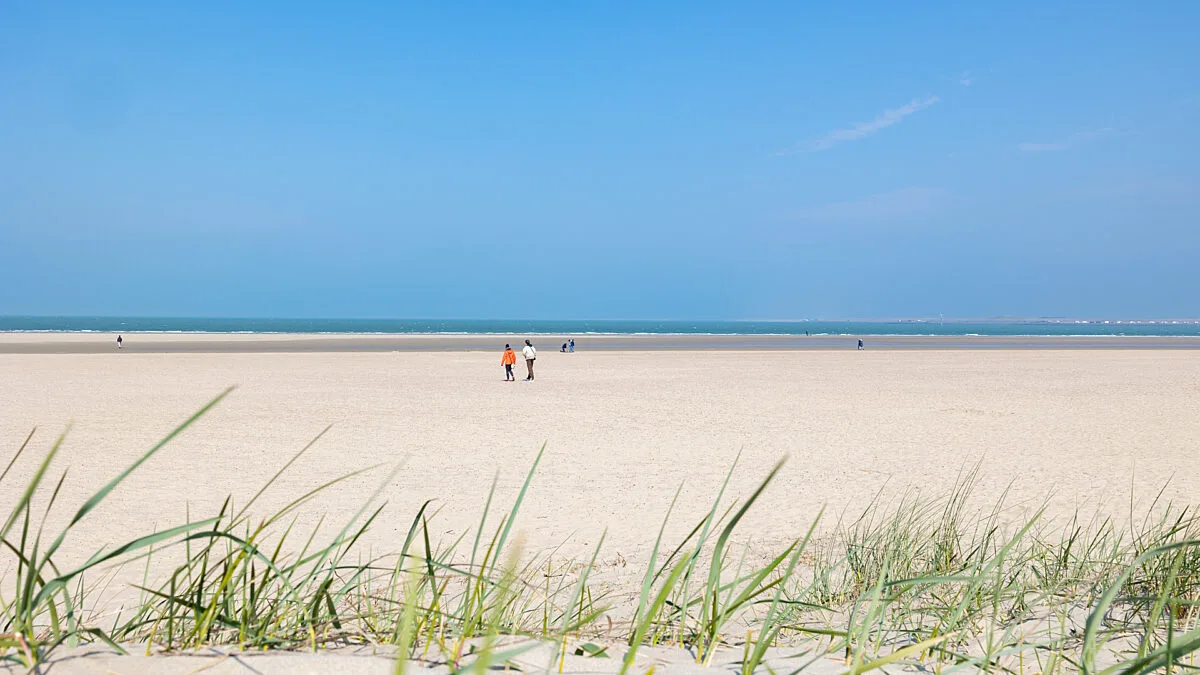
(0, 394, 1200, 674)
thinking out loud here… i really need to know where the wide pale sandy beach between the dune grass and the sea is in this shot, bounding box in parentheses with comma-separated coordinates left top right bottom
(0, 336, 1200, 667)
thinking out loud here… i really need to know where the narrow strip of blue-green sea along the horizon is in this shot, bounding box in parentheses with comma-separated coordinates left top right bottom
(0, 316, 1200, 338)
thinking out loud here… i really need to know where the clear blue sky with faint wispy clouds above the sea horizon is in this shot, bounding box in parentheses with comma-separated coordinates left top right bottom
(0, 0, 1200, 319)
